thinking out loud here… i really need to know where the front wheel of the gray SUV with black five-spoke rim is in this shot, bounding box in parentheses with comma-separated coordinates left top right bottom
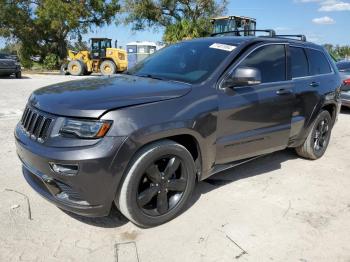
(116, 140, 196, 227)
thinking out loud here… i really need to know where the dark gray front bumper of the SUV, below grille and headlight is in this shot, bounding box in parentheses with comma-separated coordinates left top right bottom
(15, 126, 124, 217)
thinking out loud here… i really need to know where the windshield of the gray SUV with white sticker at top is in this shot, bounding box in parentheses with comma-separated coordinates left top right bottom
(127, 42, 235, 83)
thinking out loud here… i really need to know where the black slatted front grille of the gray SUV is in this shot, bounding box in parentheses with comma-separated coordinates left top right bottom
(21, 106, 53, 142)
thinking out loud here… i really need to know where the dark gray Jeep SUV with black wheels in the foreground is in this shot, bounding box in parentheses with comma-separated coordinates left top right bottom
(15, 33, 341, 227)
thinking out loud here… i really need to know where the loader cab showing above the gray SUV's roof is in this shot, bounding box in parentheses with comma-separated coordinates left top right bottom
(211, 16, 256, 36)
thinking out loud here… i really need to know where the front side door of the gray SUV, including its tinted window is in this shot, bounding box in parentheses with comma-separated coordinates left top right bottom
(216, 43, 295, 164)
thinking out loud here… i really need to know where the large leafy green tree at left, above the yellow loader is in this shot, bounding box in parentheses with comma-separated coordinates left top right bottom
(0, 0, 120, 66)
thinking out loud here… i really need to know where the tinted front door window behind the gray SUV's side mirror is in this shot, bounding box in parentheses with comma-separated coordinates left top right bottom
(240, 45, 286, 83)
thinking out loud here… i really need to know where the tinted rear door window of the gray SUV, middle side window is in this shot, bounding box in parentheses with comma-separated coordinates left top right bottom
(290, 47, 309, 78)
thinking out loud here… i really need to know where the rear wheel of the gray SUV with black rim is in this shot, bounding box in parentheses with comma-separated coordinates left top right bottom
(295, 111, 333, 160)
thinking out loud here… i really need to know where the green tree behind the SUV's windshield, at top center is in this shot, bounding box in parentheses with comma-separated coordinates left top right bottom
(124, 0, 227, 42)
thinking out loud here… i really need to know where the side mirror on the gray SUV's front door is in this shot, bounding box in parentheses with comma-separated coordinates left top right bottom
(223, 67, 261, 88)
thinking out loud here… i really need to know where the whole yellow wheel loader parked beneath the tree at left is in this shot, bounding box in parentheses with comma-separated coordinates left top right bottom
(61, 38, 128, 76)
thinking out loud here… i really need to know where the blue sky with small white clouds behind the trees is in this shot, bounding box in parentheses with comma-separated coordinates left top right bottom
(0, 0, 350, 47)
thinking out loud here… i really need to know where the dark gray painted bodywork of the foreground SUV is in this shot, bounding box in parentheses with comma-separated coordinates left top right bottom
(15, 37, 341, 216)
